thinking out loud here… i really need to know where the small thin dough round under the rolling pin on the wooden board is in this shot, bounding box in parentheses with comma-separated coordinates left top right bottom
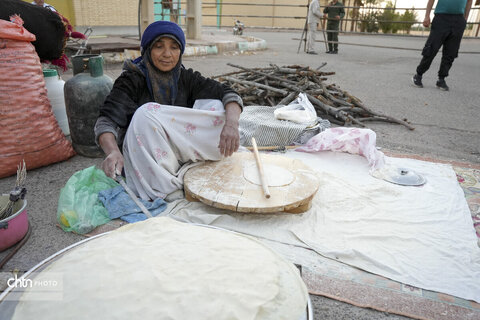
(243, 163, 295, 187)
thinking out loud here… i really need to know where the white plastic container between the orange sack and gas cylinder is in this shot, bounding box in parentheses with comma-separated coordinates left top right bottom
(43, 69, 70, 136)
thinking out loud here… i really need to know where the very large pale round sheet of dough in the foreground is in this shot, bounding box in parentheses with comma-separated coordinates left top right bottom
(13, 218, 308, 320)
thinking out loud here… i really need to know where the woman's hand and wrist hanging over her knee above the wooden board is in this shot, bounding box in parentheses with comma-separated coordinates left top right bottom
(218, 102, 242, 157)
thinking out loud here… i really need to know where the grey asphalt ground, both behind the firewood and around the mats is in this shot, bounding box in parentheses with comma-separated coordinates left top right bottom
(0, 29, 480, 319)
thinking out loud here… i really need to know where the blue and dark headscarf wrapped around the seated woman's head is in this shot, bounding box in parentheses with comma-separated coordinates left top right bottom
(129, 21, 185, 105)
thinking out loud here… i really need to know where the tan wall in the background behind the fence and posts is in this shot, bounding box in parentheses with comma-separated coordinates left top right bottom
(42, 0, 480, 36)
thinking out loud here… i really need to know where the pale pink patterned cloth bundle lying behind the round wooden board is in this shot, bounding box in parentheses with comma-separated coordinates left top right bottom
(295, 127, 385, 171)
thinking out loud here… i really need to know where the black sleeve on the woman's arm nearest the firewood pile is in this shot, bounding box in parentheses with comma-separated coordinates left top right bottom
(182, 69, 243, 110)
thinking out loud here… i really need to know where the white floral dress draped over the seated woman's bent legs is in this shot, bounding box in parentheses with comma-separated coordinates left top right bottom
(123, 100, 225, 200)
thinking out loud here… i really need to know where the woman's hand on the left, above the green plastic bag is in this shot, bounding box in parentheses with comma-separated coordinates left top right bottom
(98, 132, 124, 179)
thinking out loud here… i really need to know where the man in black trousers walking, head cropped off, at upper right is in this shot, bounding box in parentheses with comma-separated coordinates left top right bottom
(413, 0, 472, 91)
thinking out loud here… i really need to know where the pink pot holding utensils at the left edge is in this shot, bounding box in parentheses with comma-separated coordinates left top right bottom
(0, 194, 28, 251)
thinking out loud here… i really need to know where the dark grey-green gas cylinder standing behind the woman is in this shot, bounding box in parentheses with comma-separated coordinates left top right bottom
(64, 54, 113, 158)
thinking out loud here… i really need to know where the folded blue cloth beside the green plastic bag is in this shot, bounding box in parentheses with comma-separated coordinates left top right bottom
(98, 186, 167, 223)
